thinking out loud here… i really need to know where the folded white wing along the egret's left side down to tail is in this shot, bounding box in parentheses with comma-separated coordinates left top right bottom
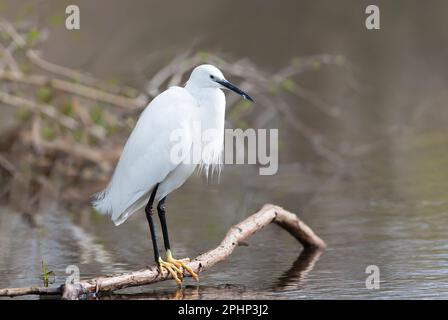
(94, 87, 198, 224)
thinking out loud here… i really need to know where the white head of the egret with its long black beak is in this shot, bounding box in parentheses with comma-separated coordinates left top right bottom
(188, 64, 254, 102)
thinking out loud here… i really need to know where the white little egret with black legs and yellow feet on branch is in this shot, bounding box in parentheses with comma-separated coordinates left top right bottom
(93, 65, 253, 284)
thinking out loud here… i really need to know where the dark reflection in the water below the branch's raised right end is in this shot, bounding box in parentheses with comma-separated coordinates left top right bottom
(272, 249, 322, 292)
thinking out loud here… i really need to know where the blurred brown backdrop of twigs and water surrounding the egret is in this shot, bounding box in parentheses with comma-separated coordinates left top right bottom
(0, 0, 448, 299)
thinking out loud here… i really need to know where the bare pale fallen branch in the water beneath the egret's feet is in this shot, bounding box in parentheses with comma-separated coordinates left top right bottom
(0, 204, 325, 299)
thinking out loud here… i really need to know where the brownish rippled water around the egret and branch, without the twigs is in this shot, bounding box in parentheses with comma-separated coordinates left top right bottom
(0, 1, 448, 299)
